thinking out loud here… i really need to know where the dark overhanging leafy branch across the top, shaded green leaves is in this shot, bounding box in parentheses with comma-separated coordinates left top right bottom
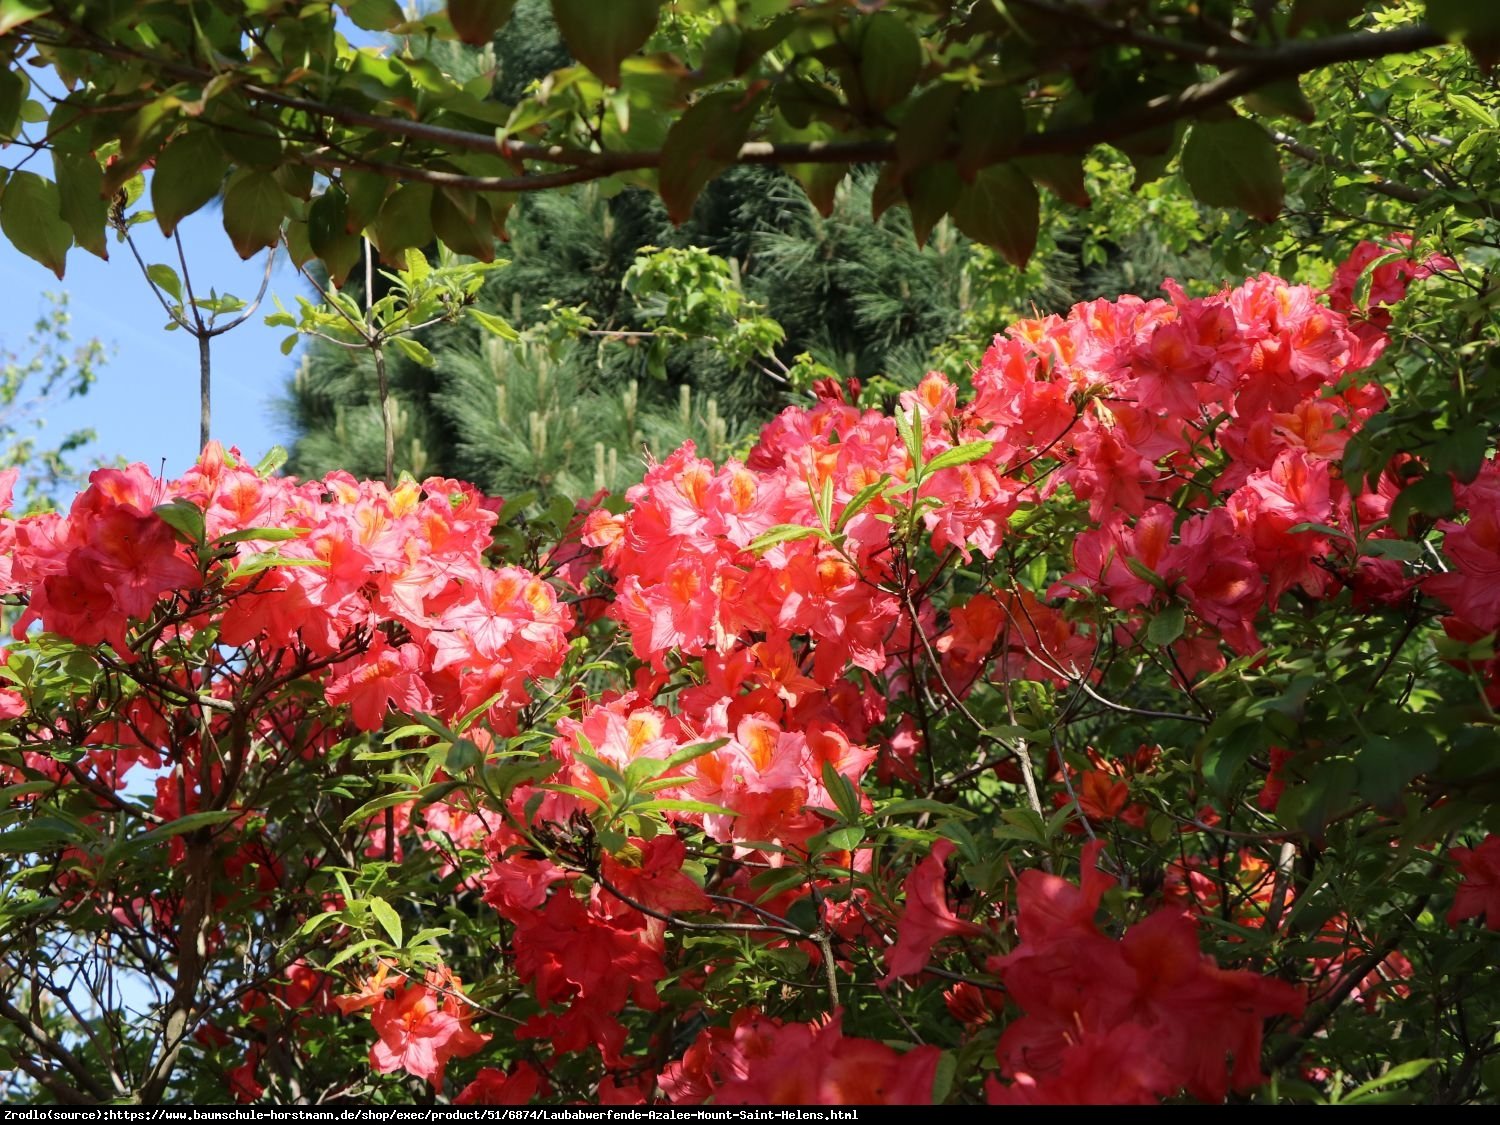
(0, 0, 1500, 278)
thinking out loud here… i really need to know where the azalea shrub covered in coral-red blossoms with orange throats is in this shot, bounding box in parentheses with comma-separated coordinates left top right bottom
(0, 240, 1500, 1106)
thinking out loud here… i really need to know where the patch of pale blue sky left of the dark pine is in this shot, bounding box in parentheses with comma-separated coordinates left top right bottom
(0, 196, 305, 476)
